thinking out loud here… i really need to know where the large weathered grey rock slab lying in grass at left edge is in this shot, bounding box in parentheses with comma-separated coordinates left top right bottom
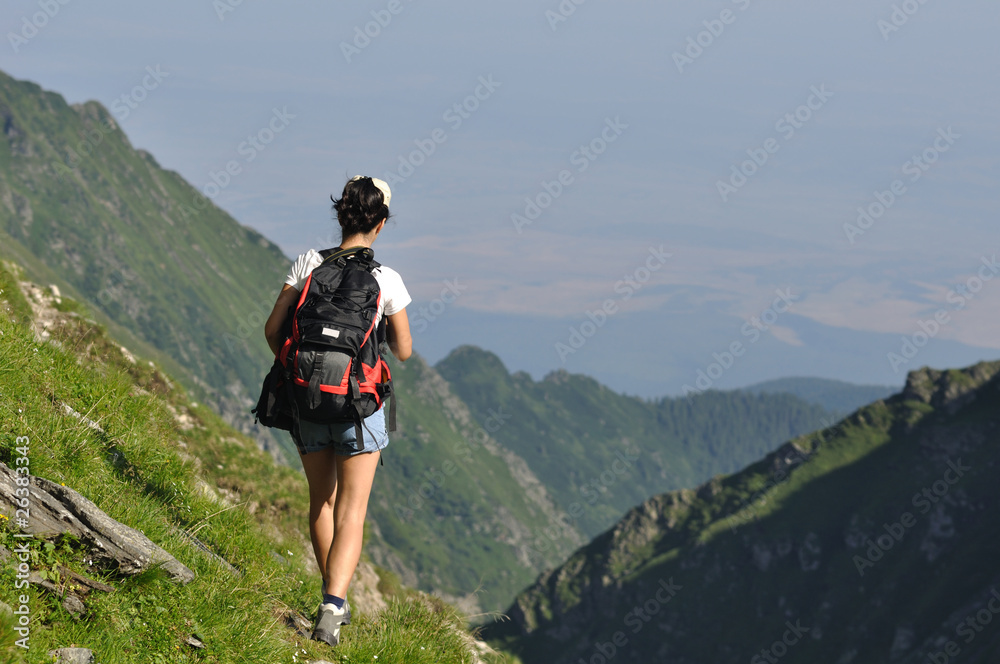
(0, 463, 194, 583)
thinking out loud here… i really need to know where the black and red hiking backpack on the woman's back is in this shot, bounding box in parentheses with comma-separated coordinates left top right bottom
(255, 247, 396, 442)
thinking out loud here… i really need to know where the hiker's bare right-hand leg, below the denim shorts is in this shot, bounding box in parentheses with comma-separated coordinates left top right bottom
(324, 452, 381, 597)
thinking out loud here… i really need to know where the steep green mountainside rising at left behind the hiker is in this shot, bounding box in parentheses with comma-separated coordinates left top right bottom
(0, 72, 294, 458)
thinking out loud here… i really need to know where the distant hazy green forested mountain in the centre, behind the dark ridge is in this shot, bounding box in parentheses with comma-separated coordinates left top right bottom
(436, 346, 832, 552)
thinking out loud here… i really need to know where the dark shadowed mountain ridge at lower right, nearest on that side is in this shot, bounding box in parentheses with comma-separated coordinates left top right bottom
(488, 362, 1000, 664)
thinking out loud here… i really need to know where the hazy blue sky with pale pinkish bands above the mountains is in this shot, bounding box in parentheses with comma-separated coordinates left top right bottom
(0, 0, 1000, 396)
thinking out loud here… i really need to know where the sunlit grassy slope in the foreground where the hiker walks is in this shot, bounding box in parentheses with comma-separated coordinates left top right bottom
(0, 271, 504, 664)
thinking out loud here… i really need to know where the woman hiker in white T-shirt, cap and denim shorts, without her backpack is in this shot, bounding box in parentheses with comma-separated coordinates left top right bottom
(264, 175, 412, 645)
